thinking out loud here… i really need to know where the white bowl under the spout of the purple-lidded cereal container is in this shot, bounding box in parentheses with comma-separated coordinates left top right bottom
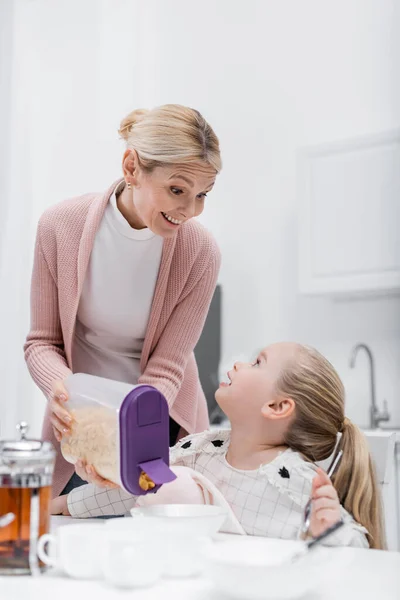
(130, 504, 227, 537)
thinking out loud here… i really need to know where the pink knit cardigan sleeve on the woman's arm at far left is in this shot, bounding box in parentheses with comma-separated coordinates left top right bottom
(24, 222, 71, 397)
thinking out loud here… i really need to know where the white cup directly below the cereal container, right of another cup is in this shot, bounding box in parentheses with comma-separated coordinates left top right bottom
(102, 527, 163, 588)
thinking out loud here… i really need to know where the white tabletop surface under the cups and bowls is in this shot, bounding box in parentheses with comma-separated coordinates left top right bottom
(0, 517, 400, 600)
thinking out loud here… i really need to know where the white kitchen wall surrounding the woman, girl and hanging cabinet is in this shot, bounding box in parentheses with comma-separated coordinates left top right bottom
(0, 0, 400, 440)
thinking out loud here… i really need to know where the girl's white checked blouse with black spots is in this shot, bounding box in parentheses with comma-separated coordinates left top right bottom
(68, 430, 368, 547)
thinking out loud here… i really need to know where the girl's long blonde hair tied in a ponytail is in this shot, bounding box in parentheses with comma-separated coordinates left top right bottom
(277, 345, 386, 549)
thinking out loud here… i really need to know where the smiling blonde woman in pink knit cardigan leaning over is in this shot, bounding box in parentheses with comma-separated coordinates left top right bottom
(25, 105, 221, 496)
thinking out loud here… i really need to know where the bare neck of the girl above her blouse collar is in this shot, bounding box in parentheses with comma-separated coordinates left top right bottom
(226, 429, 288, 471)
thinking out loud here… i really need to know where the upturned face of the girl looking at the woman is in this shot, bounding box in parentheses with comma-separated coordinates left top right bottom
(215, 343, 298, 422)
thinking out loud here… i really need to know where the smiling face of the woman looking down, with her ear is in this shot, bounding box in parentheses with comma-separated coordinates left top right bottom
(125, 152, 216, 237)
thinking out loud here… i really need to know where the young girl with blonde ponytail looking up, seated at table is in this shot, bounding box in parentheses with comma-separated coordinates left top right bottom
(52, 343, 385, 548)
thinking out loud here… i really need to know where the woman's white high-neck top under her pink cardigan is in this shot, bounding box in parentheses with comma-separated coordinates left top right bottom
(72, 188, 163, 384)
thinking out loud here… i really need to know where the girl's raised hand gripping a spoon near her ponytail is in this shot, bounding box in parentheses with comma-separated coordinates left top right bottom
(309, 469, 341, 537)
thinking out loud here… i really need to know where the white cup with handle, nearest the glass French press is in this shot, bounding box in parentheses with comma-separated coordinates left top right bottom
(37, 523, 105, 579)
